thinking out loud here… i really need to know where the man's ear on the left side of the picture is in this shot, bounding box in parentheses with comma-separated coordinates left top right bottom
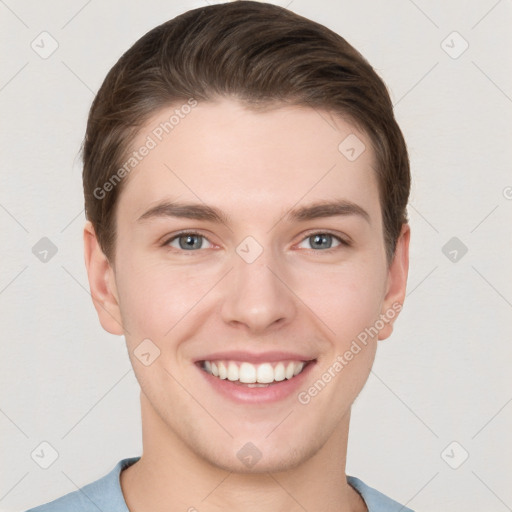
(84, 221, 124, 335)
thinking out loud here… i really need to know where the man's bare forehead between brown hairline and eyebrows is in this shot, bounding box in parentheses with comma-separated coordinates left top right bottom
(118, 100, 380, 225)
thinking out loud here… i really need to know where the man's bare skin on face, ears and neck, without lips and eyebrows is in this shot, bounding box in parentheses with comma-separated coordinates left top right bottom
(84, 99, 409, 512)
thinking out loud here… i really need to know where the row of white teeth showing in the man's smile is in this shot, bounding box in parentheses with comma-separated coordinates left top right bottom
(203, 361, 304, 387)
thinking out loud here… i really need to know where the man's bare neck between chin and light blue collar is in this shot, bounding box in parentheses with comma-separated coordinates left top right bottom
(121, 394, 367, 512)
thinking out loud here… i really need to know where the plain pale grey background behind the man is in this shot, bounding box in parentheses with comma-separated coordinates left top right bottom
(0, 0, 512, 512)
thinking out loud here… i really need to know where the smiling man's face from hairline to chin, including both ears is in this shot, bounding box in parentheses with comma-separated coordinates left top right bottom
(86, 99, 408, 472)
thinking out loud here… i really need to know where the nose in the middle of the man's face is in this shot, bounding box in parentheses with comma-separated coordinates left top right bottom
(221, 245, 297, 334)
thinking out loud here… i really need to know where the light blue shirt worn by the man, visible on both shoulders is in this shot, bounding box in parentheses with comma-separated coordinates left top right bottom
(27, 457, 413, 512)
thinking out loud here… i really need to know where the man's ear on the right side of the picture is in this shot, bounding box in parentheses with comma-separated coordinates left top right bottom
(378, 224, 411, 340)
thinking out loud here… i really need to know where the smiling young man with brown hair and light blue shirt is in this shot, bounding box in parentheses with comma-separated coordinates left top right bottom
(27, 1, 410, 512)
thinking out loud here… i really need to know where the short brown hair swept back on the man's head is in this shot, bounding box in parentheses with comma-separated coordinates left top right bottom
(82, 0, 410, 261)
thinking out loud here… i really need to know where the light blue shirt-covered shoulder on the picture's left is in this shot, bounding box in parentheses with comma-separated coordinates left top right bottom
(26, 457, 139, 512)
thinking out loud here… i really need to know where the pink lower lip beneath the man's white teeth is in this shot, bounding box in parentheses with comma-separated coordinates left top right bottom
(198, 361, 315, 404)
